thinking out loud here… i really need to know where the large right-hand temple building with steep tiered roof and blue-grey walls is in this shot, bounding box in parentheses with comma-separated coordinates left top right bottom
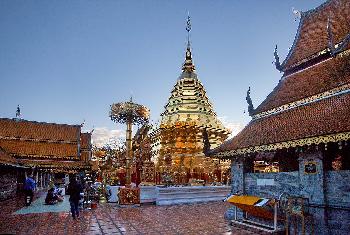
(208, 0, 350, 234)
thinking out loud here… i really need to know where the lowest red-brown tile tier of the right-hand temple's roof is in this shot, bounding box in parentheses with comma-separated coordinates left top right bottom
(213, 93, 350, 154)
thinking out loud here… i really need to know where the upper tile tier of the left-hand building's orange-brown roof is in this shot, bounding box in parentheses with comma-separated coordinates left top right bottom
(0, 118, 80, 142)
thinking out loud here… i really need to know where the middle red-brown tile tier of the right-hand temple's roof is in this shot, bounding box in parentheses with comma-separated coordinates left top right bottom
(254, 55, 350, 114)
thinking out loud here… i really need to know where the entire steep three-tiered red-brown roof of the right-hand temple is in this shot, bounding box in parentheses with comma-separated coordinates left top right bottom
(210, 0, 350, 157)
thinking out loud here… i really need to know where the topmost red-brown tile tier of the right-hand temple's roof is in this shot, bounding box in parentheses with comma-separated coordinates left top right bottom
(282, 0, 350, 70)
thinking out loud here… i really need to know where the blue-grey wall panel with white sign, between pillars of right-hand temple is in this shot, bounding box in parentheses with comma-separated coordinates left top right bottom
(244, 171, 300, 198)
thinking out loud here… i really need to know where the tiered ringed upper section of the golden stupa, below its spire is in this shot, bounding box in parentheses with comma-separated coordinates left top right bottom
(160, 47, 230, 151)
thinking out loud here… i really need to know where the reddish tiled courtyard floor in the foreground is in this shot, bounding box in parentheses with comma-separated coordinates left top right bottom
(0, 194, 255, 235)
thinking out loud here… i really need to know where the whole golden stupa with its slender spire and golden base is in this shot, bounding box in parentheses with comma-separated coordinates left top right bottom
(152, 17, 230, 184)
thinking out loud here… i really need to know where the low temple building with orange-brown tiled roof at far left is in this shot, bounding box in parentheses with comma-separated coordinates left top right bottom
(0, 114, 91, 199)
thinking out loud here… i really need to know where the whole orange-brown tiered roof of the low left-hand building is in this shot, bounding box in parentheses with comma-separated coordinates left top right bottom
(0, 118, 91, 170)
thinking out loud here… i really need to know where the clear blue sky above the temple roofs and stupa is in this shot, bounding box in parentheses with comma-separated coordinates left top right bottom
(0, 0, 323, 145)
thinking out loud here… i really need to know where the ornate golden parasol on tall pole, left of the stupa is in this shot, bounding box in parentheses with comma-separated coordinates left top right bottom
(109, 98, 149, 204)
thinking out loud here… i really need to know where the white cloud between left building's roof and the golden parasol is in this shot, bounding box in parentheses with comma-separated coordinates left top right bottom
(92, 127, 125, 147)
